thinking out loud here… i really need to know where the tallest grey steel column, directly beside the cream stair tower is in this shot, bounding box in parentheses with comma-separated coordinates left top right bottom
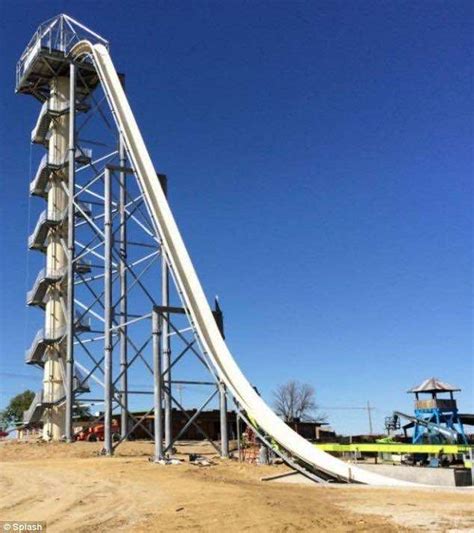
(65, 63, 76, 442)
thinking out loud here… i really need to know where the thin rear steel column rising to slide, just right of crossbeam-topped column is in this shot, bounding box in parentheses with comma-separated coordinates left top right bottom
(119, 135, 128, 439)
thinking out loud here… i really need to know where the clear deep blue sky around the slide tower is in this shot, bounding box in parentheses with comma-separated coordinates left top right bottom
(0, 0, 474, 432)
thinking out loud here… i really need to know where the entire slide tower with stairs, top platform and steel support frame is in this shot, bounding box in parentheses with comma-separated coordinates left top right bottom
(16, 14, 229, 461)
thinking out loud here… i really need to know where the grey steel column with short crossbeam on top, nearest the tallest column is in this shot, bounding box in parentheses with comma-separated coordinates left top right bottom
(104, 168, 113, 455)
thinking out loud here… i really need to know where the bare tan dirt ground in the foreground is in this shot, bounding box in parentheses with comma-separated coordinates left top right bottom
(0, 442, 474, 533)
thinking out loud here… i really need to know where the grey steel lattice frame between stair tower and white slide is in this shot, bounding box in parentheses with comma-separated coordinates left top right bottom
(21, 15, 228, 460)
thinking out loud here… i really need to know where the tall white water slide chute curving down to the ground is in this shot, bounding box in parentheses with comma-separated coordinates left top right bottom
(71, 41, 416, 486)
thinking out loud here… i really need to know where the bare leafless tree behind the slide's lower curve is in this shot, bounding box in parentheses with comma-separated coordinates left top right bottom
(273, 380, 326, 422)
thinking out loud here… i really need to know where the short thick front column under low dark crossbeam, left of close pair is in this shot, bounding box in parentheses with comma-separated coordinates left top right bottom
(151, 308, 163, 463)
